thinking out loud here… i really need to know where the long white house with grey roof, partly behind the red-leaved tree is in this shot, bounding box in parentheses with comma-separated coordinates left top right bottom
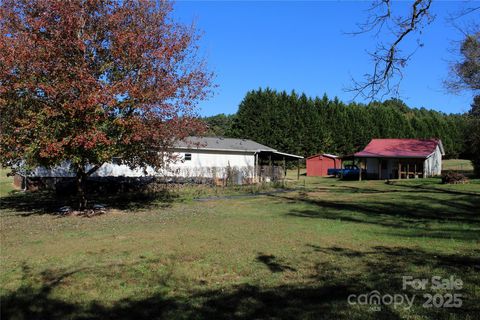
(16, 137, 302, 188)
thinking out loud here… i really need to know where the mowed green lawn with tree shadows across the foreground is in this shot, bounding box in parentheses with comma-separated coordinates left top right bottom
(0, 164, 480, 319)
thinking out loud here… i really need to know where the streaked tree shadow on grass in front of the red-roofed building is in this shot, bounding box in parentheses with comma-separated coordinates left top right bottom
(269, 182, 480, 240)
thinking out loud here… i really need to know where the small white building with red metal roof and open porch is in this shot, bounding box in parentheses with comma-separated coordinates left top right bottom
(354, 139, 445, 179)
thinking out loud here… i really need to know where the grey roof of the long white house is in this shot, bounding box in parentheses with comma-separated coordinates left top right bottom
(174, 137, 303, 159)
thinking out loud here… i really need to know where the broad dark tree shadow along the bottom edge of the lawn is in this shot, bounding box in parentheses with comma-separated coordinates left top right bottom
(1, 244, 480, 320)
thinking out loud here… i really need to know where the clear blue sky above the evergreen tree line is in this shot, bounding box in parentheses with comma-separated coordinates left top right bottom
(174, 1, 478, 115)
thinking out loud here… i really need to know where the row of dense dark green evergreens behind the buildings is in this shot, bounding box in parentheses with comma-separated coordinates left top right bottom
(205, 88, 469, 158)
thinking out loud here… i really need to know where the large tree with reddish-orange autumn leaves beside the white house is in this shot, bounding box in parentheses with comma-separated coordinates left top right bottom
(0, 0, 211, 207)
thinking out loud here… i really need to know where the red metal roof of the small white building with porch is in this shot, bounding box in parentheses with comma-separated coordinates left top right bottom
(354, 139, 444, 158)
